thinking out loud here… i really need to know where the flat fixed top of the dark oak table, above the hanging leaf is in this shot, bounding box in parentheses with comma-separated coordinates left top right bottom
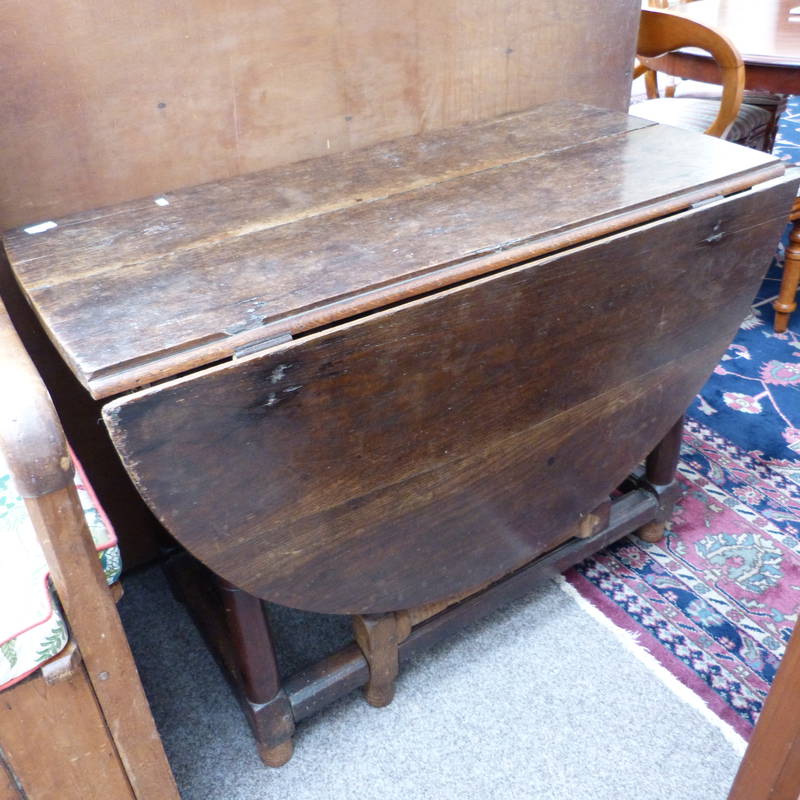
(5, 104, 783, 397)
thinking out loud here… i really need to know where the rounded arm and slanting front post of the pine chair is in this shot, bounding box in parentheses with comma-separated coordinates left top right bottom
(0, 302, 179, 800)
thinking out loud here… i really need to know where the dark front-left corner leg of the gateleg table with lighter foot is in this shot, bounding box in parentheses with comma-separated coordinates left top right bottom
(218, 578, 294, 767)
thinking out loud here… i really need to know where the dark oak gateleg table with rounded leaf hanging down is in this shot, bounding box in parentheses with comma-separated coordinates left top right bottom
(4, 103, 798, 765)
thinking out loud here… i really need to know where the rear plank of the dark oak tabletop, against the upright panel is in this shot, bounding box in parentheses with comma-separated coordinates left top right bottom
(5, 102, 652, 272)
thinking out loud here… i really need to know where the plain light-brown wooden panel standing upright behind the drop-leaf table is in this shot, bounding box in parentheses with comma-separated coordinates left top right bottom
(0, 0, 639, 228)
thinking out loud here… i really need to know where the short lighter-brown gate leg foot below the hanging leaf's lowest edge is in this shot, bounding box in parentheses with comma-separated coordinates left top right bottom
(353, 613, 401, 708)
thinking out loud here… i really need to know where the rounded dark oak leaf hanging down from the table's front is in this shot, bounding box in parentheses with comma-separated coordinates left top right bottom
(104, 179, 796, 613)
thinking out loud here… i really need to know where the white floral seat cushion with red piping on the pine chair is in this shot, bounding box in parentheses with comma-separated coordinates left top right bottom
(0, 446, 121, 691)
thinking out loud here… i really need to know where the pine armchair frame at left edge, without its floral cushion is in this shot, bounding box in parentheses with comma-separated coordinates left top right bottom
(0, 303, 178, 800)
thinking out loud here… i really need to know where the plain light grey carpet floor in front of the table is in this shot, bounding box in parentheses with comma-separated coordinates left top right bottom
(120, 568, 739, 800)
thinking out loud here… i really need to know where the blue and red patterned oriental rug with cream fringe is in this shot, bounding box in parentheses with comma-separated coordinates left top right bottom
(567, 97, 800, 737)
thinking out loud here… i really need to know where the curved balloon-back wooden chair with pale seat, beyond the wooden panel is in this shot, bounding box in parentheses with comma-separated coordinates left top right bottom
(630, 10, 773, 149)
